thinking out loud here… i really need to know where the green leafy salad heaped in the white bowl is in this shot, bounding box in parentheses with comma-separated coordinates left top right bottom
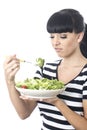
(16, 78, 64, 90)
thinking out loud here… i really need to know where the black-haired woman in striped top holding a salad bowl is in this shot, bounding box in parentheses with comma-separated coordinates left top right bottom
(4, 9, 87, 130)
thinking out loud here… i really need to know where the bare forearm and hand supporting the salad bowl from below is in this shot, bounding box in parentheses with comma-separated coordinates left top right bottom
(44, 98, 87, 130)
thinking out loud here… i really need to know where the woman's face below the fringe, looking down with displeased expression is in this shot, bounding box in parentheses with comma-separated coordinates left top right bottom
(51, 32, 79, 57)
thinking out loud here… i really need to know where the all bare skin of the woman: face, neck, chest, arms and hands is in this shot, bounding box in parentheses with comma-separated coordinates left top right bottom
(4, 32, 87, 130)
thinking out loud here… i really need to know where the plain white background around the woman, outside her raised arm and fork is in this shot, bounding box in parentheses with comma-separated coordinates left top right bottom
(0, 0, 87, 130)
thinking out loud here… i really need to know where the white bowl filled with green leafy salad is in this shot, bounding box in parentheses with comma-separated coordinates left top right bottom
(15, 78, 65, 98)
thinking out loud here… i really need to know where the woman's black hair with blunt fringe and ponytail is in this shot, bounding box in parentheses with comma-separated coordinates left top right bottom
(47, 9, 87, 57)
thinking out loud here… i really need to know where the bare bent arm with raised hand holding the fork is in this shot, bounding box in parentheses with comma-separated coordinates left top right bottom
(4, 55, 37, 119)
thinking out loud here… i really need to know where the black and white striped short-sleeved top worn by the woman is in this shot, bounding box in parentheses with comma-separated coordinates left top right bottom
(35, 60, 87, 130)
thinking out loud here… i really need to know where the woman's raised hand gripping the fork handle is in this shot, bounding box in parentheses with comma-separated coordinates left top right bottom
(4, 55, 20, 85)
